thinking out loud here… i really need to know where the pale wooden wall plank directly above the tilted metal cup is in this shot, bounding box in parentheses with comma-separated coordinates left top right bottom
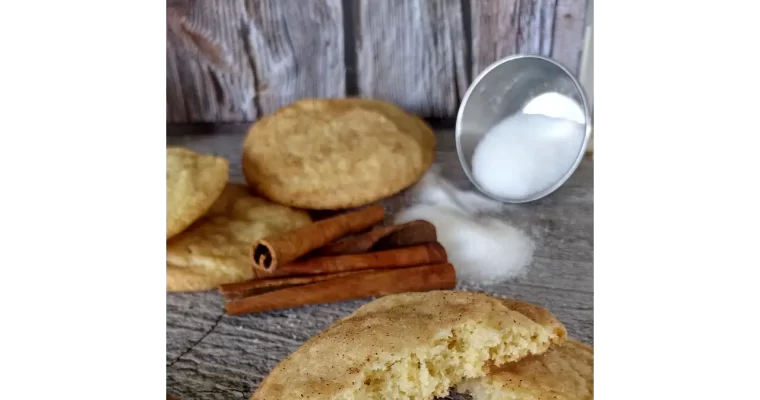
(470, 0, 587, 76)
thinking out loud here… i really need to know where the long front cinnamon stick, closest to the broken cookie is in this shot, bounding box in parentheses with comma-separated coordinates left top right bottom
(224, 263, 456, 315)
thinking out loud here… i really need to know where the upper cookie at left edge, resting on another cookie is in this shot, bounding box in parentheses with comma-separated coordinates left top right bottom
(166, 147, 230, 240)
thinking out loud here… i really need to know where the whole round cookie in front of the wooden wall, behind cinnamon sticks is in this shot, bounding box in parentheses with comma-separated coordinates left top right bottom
(243, 98, 435, 210)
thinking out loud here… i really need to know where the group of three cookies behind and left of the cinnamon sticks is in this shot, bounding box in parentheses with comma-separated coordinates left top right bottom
(166, 99, 435, 291)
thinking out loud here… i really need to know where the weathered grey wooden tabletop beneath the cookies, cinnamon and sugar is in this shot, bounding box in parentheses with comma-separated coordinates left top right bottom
(166, 129, 594, 400)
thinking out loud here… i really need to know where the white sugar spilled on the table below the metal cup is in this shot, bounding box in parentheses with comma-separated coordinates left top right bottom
(394, 169, 534, 284)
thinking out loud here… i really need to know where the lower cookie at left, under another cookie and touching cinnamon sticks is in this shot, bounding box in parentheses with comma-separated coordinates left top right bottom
(166, 184, 311, 292)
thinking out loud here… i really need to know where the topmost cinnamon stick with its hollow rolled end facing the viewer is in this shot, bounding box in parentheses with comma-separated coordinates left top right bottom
(251, 205, 385, 272)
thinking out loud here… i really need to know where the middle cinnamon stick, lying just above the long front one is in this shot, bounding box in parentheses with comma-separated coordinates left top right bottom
(275, 242, 448, 275)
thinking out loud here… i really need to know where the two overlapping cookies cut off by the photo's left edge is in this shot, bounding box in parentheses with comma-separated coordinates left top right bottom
(166, 148, 311, 291)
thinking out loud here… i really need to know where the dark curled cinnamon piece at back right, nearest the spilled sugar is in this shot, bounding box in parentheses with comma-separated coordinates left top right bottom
(314, 220, 438, 256)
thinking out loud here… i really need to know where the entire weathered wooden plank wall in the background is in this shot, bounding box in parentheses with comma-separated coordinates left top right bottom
(166, 0, 587, 123)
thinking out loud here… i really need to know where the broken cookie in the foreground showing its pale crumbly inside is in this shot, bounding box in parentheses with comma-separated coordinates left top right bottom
(252, 291, 566, 400)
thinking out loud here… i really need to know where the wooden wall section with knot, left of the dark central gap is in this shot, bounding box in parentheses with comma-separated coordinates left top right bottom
(166, 0, 345, 123)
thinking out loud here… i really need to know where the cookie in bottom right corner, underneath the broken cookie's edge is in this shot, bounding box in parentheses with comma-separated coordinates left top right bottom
(457, 339, 594, 400)
